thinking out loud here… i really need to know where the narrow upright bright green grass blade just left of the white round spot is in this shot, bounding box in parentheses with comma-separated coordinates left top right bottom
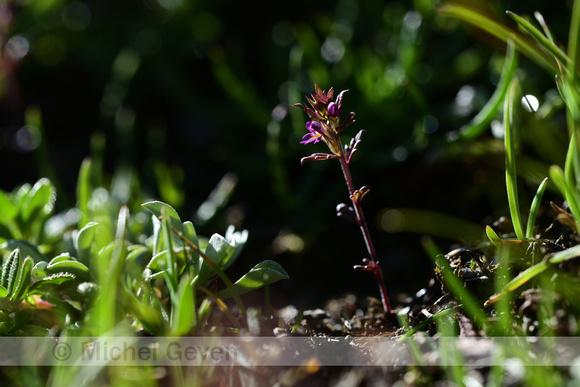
(503, 78, 525, 240)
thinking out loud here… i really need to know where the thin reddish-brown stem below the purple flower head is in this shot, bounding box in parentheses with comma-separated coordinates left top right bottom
(338, 153, 391, 314)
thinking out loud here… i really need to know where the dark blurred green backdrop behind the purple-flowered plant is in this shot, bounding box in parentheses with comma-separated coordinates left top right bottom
(0, 0, 571, 308)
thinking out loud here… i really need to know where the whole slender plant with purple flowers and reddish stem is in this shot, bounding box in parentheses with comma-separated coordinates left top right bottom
(294, 83, 391, 313)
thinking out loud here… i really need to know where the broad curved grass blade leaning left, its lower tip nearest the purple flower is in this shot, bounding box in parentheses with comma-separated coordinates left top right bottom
(459, 40, 518, 139)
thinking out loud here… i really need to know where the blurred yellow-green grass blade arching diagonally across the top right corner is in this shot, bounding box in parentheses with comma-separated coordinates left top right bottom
(439, 4, 559, 73)
